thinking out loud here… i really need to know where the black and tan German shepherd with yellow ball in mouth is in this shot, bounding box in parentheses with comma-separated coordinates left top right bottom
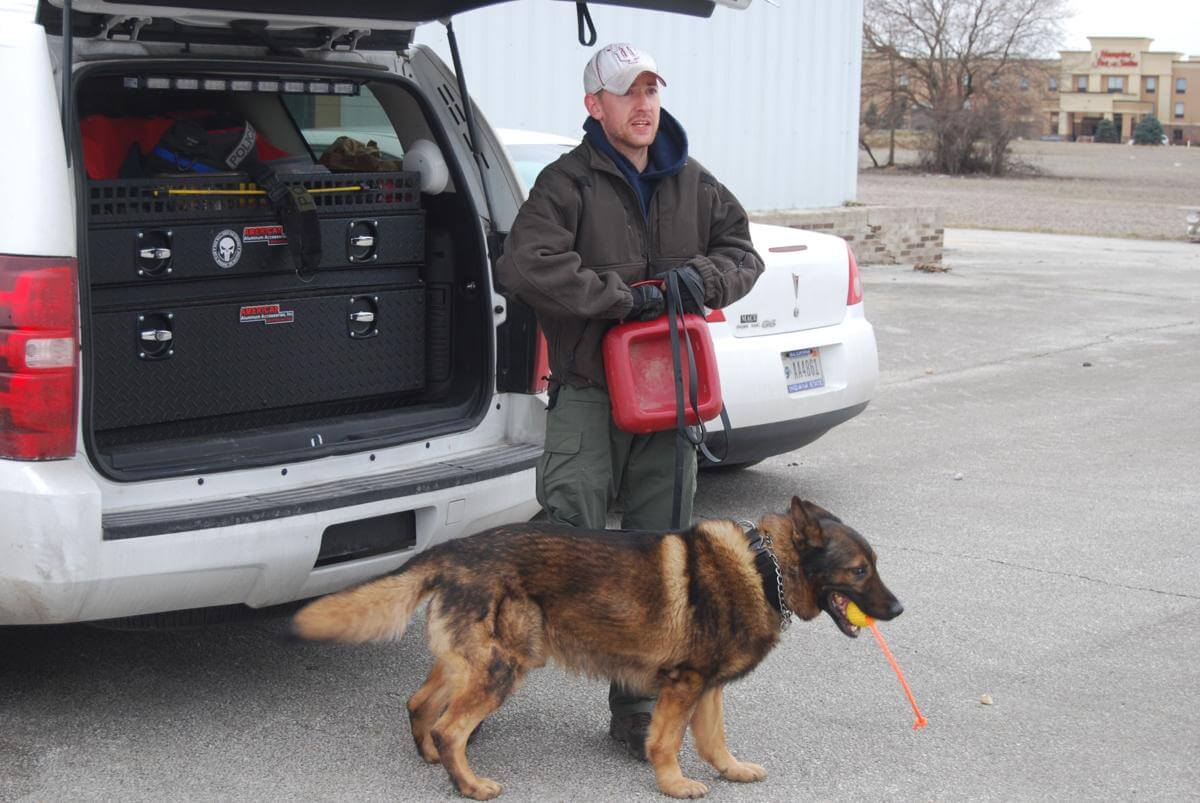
(293, 497, 904, 801)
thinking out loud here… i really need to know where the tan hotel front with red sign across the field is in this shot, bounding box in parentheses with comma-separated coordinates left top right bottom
(1045, 36, 1200, 144)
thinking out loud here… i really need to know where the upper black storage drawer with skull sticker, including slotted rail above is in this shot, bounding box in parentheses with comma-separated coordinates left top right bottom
(88, 172, 425, 284)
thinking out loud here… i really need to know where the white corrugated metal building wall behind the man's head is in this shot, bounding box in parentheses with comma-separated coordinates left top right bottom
(416, 0, 863, 209)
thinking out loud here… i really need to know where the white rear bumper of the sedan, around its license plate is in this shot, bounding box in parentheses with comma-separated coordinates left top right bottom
(707, 304, 880, 463)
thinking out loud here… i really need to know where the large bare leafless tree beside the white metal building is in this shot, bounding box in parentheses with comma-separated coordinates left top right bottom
(863, 0, 1067, 174)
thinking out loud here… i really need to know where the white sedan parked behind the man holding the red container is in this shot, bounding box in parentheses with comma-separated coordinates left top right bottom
(497, 128, 880, 467)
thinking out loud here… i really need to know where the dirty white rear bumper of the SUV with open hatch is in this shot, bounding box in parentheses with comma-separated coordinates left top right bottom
(0, 445, 540, 625)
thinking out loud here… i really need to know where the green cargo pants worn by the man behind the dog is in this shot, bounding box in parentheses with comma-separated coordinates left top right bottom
(538, 385, 696, 717)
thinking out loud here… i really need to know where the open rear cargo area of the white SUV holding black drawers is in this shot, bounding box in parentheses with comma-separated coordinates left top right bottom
(76, 60, 493, 479)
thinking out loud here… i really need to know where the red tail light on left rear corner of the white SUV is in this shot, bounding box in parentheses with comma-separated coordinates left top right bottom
(0, 256, 79, 460)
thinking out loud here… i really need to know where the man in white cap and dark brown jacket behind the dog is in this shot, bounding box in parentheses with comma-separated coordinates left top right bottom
(496, 44, 763, 760)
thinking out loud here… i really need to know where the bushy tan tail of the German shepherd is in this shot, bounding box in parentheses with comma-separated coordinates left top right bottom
(292, 558, 437, 643)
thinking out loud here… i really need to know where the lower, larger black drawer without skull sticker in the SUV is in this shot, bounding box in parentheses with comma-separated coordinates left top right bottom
(91, 284, 426, 430)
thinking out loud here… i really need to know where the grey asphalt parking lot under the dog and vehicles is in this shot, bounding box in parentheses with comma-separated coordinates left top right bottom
(0, 229, 1200, 801)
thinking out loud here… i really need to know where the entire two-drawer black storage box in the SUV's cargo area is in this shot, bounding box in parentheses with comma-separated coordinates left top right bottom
(88, 173, 426, 431)
